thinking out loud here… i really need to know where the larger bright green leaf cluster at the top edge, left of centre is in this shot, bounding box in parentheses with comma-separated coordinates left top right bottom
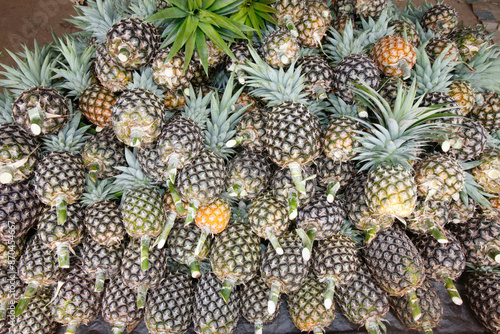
(147, 0, 253, 75)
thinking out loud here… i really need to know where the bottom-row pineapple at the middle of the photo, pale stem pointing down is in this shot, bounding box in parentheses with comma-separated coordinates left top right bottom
(240, 276, 281, 334)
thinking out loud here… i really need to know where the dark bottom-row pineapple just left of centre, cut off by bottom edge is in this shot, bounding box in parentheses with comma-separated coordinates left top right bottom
(193, 273, 240, 334)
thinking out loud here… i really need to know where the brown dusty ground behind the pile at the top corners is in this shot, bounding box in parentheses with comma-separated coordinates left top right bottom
(0, 0, 500, 65)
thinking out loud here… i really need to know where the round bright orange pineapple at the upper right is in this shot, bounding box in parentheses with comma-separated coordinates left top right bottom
(371, 35, 417, 79)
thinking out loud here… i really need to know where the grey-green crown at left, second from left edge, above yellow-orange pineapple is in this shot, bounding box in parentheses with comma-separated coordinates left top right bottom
(54, 35, 95, 98)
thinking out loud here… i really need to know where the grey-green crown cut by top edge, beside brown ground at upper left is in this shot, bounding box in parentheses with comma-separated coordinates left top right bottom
(67, 0, 128, 44)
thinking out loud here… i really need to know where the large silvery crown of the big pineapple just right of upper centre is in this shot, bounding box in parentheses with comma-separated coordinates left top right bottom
(238, 45, 308, 107)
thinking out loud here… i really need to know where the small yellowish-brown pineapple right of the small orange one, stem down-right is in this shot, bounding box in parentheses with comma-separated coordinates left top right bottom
(248, 191, 290, 255)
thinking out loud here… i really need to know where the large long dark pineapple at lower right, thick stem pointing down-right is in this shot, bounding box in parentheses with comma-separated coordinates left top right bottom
(363, 226, 425, 321)
